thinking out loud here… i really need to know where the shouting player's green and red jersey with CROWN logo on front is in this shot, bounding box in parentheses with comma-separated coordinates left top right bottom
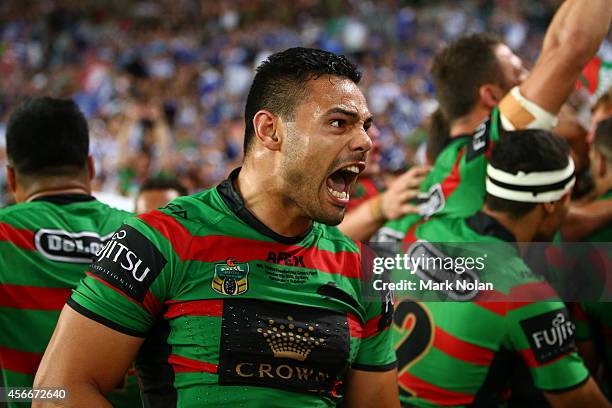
(68, 170, 396, 407)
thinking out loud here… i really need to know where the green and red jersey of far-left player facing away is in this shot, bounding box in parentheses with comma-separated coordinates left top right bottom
(0, 195, 140, 407)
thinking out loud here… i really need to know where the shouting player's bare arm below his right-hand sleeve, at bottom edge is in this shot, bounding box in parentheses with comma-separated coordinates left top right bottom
(346, 369, 400, 408)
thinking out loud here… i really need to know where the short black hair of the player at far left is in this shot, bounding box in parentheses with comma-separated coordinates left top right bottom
(6, 97, 89, 176)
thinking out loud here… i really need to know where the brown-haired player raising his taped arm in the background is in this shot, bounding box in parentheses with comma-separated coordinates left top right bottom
(385, 0, 612, 241)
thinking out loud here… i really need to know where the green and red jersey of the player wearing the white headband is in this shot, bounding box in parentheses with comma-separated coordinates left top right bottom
(392, 212, 589, 407)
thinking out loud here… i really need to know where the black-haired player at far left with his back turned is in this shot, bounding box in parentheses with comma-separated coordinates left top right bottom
(0, 98, 140, 407)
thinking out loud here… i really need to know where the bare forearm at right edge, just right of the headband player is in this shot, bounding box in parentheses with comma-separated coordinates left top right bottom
(561, 199, 612, 242)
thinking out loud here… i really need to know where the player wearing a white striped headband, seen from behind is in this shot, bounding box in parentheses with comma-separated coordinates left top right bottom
(393, 130, 609, 407)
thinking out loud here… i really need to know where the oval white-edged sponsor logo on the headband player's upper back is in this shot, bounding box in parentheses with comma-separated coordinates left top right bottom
(406, 240, 480, 301)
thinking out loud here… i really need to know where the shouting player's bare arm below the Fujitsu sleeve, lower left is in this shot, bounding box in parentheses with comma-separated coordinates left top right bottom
(32, 306, 144, 408)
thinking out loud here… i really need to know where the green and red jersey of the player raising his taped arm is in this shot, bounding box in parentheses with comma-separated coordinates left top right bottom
(375, 107, 503, 242)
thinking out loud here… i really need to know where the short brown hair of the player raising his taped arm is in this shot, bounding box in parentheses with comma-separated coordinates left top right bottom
(431, 33, 504, 121)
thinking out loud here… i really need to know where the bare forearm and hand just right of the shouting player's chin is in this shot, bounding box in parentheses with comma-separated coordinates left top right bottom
(338, 166, 429, 241)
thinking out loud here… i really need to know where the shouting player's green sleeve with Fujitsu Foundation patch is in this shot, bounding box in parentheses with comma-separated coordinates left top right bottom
(68, 218, 175, 337)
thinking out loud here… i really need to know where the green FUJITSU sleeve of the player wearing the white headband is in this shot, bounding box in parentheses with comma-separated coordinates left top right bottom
(505, 301, 589, 392)
